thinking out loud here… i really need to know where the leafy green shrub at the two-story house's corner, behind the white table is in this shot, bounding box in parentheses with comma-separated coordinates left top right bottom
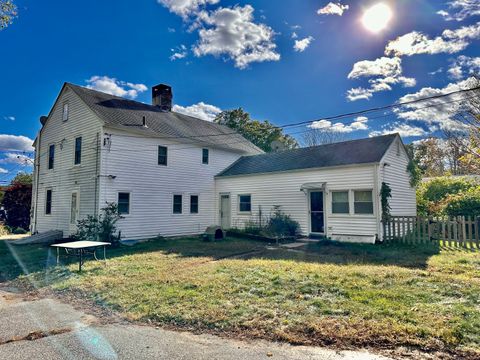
(74, 203, 122, 245)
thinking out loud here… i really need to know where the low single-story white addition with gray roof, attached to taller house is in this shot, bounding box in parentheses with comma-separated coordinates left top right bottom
(215, 134, 416, 243)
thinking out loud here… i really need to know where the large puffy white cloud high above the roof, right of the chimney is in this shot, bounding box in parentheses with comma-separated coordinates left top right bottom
(194, 5, 280, 69)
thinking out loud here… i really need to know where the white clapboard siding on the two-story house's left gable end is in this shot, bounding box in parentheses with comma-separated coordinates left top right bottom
(32, 87, 102, 236)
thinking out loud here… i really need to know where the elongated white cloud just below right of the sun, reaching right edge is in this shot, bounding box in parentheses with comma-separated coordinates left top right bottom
(385, 22, 480, 56)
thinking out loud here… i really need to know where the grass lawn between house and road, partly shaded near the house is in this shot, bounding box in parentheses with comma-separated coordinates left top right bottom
(0, 239, 480, 354)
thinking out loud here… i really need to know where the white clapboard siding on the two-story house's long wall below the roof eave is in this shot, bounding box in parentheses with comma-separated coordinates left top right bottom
(100, 129, 241, 239)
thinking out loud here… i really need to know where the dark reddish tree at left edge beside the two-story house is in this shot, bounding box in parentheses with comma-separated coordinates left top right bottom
(3, 173, 32, 230)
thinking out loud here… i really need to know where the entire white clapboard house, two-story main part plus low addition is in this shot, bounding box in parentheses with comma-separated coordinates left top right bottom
(31, 83, 416, 242)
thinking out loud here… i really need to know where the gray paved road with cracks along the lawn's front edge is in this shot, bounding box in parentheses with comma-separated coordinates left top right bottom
(0, 290, 394, 360)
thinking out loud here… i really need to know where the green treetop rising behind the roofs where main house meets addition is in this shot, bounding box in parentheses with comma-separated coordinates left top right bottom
(214, 108, 298, 152)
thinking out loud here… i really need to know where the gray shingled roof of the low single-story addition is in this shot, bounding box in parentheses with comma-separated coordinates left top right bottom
(217, 134, 398, 177)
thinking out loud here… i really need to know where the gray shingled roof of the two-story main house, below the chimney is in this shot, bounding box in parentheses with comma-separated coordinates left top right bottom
(66, 83, 262, 154)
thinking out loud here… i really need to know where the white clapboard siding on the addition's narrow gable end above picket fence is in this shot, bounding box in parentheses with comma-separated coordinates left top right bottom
(380, 138, 417, 216)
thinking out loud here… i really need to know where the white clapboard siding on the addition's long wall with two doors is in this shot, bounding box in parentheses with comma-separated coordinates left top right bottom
(215, 165, 379, 238)
